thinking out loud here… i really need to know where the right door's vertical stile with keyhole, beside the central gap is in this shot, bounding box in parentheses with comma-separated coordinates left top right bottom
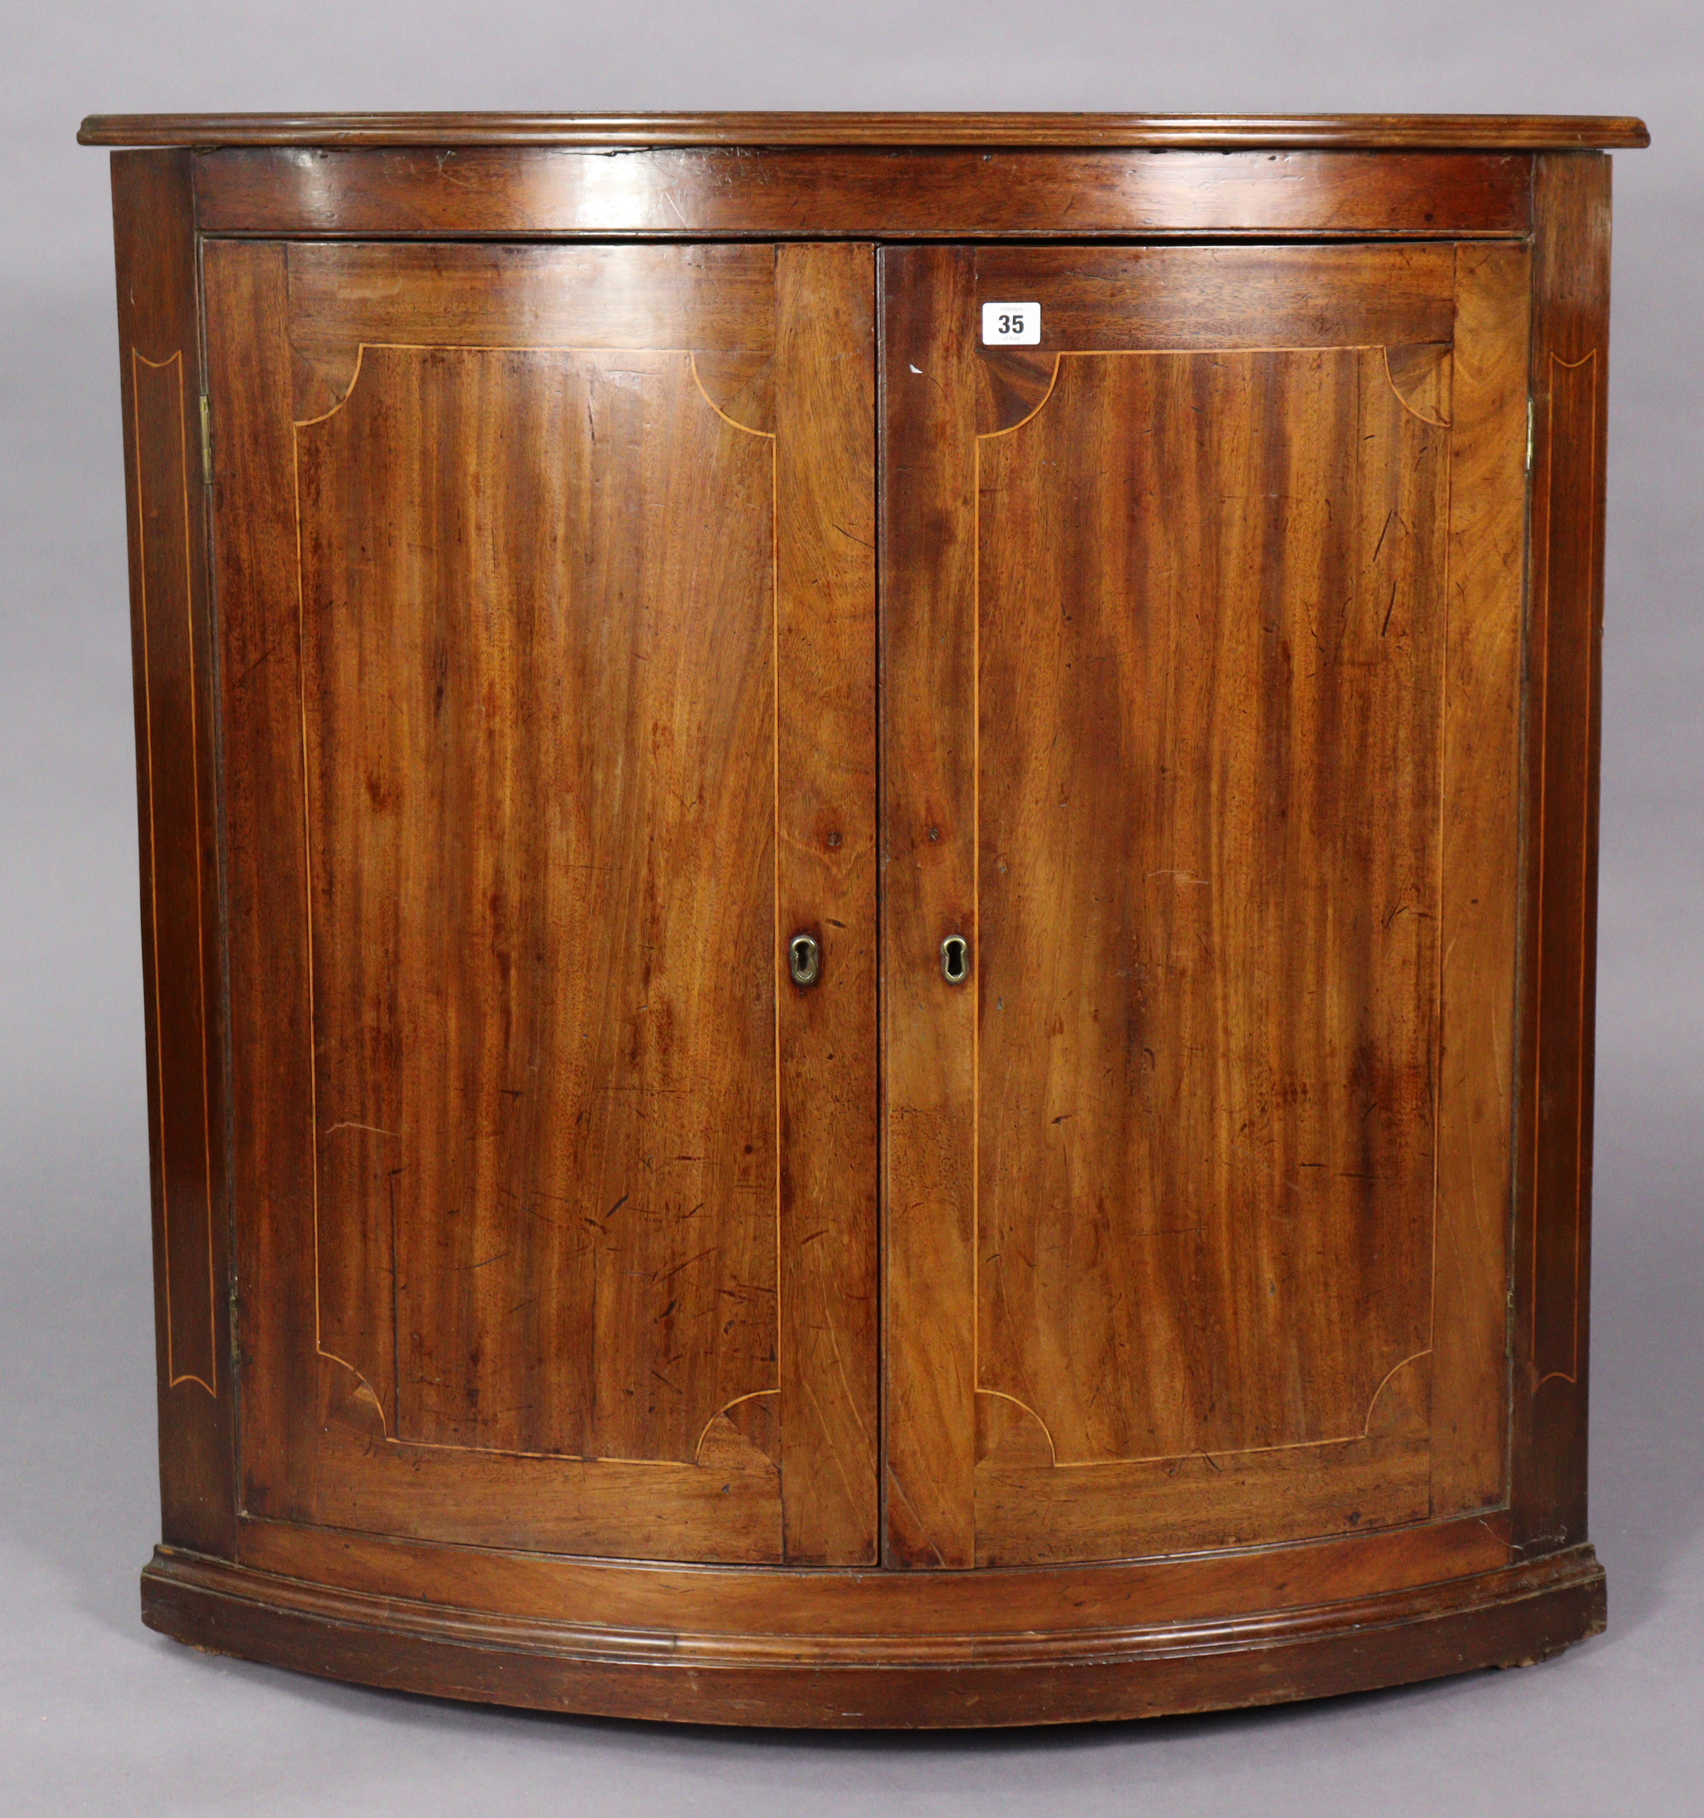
(880, 247, 977, 1567)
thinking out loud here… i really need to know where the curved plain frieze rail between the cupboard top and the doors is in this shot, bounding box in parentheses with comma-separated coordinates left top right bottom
(195, 145, 1531, 242)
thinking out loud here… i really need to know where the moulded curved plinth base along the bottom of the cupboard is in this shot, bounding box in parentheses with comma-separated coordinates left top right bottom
(144, 1547, 1604, 1729)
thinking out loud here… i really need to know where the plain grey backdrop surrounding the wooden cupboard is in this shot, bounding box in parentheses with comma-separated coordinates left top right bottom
(0, 0, 1704, 1818)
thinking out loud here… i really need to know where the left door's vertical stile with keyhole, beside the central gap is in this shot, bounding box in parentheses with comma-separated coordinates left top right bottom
(775, 245, 878, 1565)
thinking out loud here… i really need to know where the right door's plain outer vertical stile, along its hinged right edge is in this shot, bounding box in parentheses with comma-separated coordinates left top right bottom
(1431, 245, 1528, 1516)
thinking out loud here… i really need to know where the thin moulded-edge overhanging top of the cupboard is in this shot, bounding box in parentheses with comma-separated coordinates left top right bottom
(76, 113, 1651, 151)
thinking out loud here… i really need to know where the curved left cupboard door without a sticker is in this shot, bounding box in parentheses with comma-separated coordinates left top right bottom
(204, 240, 877, 1565)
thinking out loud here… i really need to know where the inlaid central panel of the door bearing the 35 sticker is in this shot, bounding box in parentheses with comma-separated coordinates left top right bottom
(978, 341, 1446, 1476)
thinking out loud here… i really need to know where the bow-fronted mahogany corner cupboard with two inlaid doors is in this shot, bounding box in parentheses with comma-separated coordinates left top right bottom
(82, 115, 1646, 1727)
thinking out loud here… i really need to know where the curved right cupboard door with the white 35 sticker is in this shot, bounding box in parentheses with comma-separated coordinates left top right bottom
(884, 244, 1529, 1567)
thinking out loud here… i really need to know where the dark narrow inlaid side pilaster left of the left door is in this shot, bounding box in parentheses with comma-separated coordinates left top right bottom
(113, 151, 235, 1553)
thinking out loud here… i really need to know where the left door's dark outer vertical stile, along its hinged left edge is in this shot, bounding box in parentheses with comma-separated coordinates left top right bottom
(202, 245, 307, 1509)
